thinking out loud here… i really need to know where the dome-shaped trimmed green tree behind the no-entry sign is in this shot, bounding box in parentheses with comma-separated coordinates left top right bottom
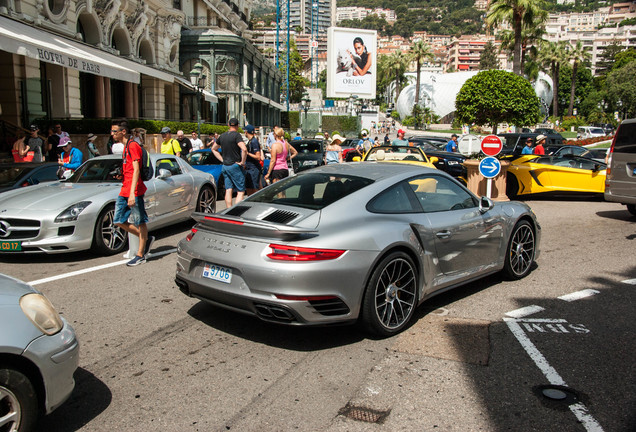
(455, 70, 541, 133)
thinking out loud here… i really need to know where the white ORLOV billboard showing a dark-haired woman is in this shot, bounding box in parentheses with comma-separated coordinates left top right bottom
(327, 27, 378, 99)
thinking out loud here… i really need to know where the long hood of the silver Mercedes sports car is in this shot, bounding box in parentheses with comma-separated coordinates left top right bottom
(0, 182, 121, 216)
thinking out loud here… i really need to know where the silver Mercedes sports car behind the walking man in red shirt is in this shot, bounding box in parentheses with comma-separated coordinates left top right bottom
(0, 153, 216, 255)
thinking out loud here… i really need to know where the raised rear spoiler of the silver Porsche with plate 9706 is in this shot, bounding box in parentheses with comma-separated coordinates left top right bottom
(192, 212, 318, 241)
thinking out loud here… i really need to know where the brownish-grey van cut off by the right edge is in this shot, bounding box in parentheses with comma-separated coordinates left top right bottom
(605, 119, 636, 216)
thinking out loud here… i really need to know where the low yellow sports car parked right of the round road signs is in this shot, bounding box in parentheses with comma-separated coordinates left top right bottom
(506, 155, 607, 199)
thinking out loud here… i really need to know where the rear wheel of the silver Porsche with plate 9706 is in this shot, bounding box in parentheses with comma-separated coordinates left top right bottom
(362, 252, 417, 336)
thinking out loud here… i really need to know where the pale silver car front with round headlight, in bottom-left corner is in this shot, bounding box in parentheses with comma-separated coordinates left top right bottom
(0, 274, 79, 432)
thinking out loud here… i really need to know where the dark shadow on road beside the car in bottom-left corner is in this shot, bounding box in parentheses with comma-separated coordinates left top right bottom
(37, 368, 112, 432)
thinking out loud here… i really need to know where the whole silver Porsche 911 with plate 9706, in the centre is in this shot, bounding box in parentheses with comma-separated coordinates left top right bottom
(176, 162, 541, 336)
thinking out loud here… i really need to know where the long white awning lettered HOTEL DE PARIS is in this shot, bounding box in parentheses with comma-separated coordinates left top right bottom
(0, 16, 175, 84)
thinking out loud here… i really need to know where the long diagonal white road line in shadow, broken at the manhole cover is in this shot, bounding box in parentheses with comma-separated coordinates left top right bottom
(503, 318, 603, 432)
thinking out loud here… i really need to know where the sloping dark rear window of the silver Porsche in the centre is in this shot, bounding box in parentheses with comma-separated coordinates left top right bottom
(246, 173, 373, 210)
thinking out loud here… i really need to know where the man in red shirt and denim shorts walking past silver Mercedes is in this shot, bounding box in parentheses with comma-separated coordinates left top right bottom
(111, 120, 155, 267)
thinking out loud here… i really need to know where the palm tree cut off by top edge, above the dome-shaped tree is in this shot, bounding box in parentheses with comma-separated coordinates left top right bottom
(486, 0, 548, 75)
